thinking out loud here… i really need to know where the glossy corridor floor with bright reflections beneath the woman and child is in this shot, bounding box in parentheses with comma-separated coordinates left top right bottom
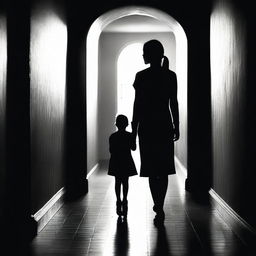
(28, 159, 256, 256)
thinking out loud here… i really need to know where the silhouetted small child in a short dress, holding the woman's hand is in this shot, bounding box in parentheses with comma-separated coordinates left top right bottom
(108, 115, 138, 217)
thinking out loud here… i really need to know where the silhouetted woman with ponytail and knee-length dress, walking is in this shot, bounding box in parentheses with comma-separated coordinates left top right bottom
(132, 39, 180, 225)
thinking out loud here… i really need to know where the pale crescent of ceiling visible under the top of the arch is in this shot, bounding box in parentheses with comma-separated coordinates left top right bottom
(103, 15, 172, 33)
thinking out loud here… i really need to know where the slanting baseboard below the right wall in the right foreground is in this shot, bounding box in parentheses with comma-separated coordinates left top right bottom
(209, 189, 256, 245)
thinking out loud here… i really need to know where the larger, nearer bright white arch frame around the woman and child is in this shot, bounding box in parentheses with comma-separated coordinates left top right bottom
(86, 6, 187, 178)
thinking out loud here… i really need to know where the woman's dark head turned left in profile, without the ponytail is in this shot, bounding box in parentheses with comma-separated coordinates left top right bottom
(143, 39, 164, 64)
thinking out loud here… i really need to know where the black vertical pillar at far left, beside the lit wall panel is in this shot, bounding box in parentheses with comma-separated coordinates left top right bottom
(3, 0, 32, 246)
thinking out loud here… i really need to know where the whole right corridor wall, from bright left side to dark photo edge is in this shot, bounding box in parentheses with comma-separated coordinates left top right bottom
(210, 0, 256, 227)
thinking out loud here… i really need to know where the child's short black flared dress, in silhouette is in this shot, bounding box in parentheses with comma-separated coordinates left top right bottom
(108, 131, 138, 178)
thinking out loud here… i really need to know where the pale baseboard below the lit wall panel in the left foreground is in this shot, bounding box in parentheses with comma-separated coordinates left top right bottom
(31, 188, 65, 233)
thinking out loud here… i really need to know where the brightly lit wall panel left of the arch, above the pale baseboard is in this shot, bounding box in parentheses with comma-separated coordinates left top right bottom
(30, 2, 67, 212)
